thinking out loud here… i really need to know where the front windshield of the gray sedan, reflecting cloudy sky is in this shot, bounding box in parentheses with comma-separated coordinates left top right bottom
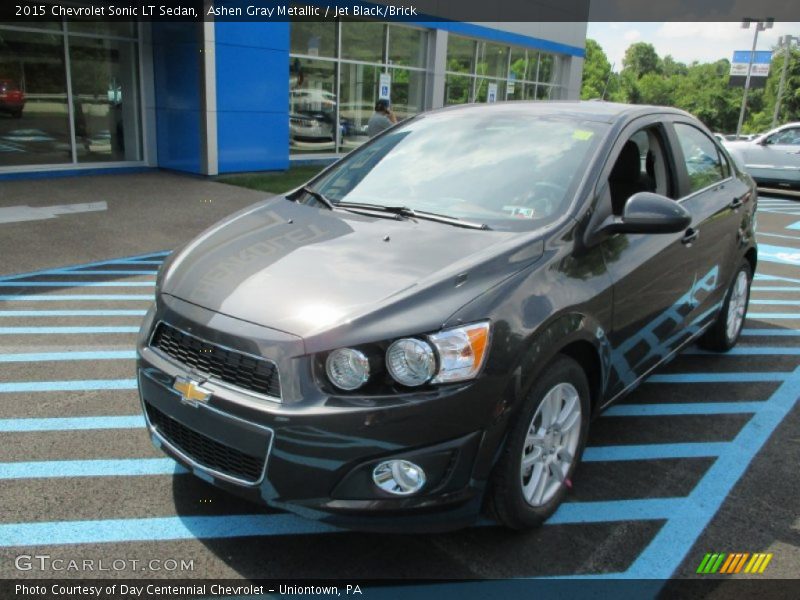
(312, 110, 608, 231)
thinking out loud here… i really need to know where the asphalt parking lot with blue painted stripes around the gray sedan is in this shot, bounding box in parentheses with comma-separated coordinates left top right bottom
(0, 176, 800, 586)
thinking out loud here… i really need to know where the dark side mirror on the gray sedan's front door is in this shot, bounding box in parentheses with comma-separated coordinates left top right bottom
(600, 192, 692, 233)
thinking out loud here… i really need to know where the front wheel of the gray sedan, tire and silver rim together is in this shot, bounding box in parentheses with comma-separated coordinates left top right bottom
(488, 355, 589, 529)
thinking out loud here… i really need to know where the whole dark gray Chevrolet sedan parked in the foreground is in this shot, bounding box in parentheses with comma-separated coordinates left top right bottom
(138, 102, 756, 531)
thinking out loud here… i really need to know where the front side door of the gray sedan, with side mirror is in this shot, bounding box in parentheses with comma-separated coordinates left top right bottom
(598, 116, 697, 397)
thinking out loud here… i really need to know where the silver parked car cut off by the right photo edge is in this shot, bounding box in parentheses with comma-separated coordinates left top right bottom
(724, 123, 800, 187)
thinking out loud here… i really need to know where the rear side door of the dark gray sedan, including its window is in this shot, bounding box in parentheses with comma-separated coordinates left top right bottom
(669, 119, 751, 344)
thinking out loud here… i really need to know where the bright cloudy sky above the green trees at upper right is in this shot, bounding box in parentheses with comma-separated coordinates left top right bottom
(586, 22, 800, 71)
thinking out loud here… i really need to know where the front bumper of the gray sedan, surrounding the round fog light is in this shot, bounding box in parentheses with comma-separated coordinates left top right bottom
(138, 296, 499, 532)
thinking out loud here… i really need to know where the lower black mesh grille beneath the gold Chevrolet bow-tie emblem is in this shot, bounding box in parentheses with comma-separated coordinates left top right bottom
(145, 403, 266, 483)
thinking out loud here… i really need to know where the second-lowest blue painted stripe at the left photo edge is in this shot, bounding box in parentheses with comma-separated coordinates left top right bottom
(0, 458, 183, 480)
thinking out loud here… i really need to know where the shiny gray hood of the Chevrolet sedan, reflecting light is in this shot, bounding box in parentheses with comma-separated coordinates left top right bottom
(161, 198, 542, 338)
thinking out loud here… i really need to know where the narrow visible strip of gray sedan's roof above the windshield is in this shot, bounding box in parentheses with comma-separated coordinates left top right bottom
(434, 100, 694, 123)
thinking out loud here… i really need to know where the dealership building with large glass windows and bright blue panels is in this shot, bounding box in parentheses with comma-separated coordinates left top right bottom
(0, 20, 586, 179)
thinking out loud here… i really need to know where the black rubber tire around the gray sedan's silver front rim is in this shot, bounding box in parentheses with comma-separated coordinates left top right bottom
(487, 355, 590, 529)
